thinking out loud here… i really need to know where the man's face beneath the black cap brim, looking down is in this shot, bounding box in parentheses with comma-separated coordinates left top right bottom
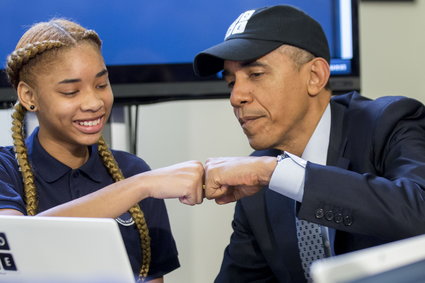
(223, 49, 311, 151)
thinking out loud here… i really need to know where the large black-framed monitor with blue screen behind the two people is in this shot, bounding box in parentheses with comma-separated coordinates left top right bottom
(0, 0, 360, 107)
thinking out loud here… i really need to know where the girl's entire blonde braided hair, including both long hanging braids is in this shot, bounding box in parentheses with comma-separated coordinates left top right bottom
(6, 19, 151, 281)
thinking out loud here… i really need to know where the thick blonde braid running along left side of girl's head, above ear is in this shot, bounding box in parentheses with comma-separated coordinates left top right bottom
(6, 40, 64, 89)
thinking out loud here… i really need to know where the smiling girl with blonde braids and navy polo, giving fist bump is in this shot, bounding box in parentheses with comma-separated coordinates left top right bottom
(0, 19, 203, 282)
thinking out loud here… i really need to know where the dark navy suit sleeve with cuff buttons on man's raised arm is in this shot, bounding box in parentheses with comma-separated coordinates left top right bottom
(299, 99, 425, 241)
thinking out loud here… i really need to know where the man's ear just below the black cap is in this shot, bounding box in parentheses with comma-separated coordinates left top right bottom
(308, 57, 330, 96)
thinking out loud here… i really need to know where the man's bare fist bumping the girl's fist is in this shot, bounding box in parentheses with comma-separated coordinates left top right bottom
(205, 156, 277, 204)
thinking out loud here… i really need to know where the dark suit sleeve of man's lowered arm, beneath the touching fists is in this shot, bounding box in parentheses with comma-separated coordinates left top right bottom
(214, 201, 276, 283)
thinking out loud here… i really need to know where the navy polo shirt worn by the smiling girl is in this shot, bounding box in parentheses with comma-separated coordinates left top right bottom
(0, 128, 180, 278)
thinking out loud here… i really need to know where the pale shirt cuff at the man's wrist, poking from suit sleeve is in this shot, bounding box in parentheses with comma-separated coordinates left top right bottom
(269, 152, 307, 202)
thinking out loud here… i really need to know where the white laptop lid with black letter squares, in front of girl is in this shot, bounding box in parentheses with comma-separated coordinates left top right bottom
(0, 216, 135, 283)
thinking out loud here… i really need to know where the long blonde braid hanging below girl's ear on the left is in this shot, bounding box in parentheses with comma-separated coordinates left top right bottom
(12, 102, 37, 215)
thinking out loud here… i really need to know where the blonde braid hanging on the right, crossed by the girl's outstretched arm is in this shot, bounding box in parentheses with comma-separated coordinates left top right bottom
(98, 137, 151, 282)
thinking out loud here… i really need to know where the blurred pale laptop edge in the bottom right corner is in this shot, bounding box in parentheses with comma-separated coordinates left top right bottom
(311, 235, 425, 283)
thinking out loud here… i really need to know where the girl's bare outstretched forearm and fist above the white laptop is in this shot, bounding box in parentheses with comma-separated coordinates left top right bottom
(34, 161, 204, 218)
